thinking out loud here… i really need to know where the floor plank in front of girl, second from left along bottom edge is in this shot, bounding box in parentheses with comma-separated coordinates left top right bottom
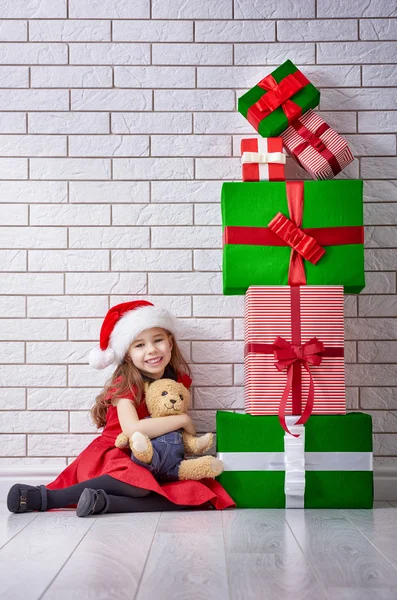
(39, 513, 160, 600)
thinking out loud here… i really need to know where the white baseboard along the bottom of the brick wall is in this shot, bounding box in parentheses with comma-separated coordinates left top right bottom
(0, 465, 397, 502)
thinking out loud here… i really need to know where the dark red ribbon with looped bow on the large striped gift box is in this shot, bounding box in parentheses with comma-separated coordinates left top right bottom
(245, 287, 344, 437)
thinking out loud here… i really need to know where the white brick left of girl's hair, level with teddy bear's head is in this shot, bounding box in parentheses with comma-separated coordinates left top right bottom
(27, 388, 95, 411)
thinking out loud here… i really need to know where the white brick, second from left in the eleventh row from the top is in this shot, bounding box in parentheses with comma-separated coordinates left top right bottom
(69, 227, 149, 248)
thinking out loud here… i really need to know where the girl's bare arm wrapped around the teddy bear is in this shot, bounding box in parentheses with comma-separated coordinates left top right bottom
(112, 398, 196, 438)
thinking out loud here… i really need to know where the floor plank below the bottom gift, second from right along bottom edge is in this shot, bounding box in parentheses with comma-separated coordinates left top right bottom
(222, 510, 325, 600)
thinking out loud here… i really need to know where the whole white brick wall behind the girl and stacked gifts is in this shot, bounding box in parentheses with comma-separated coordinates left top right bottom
(0, 0, 397, 467)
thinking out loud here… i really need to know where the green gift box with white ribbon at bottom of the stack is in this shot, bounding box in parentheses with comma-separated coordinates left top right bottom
(216, 411, 373, 508)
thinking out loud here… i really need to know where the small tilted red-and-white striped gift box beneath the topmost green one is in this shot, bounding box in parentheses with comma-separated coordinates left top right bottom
(282, 110, 354, 179)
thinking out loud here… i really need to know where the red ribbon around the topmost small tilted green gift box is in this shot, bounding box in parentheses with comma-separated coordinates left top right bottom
(247, 70, 310, 131)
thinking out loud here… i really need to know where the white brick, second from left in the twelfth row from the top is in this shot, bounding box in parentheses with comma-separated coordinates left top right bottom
(28, 250, 110, 272)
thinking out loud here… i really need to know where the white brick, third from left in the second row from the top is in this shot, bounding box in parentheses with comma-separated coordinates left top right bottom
(113, 17, 193, 42)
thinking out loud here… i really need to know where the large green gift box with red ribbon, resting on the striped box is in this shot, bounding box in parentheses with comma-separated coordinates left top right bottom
(221, 180, 365, 295)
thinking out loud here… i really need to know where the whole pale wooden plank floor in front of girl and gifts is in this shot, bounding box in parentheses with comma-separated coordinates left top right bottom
(0, 502, 397, 600)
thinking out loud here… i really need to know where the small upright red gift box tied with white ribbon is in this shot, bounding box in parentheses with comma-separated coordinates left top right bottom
(241, 137, 286, 181)
